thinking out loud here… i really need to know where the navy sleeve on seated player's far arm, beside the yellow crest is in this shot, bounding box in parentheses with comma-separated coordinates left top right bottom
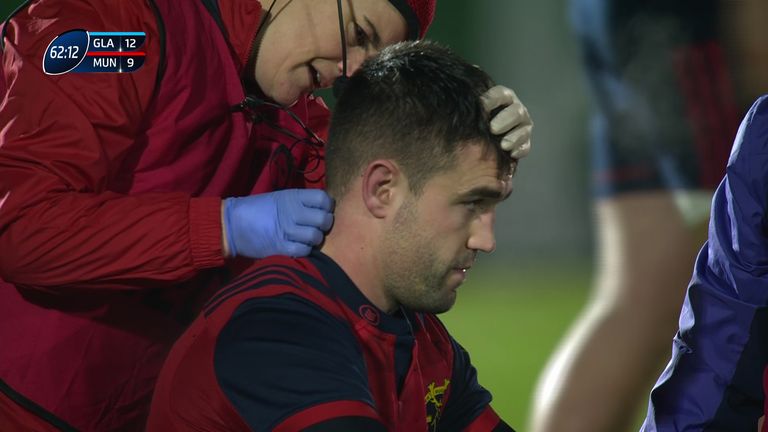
(437, 338, 498, 432)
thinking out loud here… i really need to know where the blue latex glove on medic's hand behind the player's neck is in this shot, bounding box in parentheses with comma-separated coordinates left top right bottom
(223, 189, 333, 258)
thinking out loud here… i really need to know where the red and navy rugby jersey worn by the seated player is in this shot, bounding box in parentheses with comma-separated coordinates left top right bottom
(148, 252, 512, 432)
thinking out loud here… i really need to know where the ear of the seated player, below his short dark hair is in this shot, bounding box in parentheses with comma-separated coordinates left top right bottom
(362, 159, 408, 218)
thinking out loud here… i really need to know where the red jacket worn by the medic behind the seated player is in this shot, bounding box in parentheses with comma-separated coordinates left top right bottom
(0, 0, 328, 431)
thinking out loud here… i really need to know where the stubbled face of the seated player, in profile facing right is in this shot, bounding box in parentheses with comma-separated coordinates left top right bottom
(382, 145, 511, 313)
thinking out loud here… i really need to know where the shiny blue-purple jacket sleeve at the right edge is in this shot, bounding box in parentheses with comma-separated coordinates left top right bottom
(642, 96, 768, 432)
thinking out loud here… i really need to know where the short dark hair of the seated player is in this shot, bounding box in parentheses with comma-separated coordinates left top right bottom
(326, 41, 512, 199)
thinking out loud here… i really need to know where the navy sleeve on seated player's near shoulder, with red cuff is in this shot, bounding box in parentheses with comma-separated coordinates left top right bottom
(214, 294, 375, 431)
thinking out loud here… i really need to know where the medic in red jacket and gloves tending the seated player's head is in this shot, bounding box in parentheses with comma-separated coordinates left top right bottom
(0, 0, 530, 431)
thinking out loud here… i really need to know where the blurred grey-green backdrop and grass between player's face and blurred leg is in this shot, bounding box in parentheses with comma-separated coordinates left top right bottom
(0, 0, 592, 431)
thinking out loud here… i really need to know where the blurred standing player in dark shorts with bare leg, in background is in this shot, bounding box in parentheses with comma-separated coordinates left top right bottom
(531, 0, 768, 432)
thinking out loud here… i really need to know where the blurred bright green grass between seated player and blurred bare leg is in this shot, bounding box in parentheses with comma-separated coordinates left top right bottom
(441, 265, 591, 430)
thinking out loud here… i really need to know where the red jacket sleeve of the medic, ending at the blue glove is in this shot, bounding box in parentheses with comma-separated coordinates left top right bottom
(0, 0, 223, 289)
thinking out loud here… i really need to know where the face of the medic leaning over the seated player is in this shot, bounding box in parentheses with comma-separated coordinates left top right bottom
(255, 0, 406, 105)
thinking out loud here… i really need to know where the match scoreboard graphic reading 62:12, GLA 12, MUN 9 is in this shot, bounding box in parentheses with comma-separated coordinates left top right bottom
(43, 29, 147, 75)
